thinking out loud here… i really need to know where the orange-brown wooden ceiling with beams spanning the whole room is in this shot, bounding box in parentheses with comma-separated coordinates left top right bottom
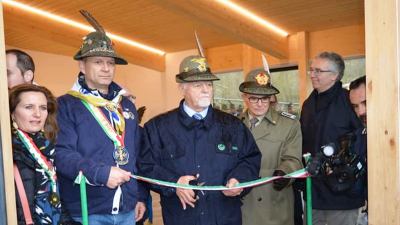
(3, 0, 364, 71)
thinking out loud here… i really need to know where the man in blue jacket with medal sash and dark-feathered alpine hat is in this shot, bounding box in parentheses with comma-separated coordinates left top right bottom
(56, 11, 147, 225)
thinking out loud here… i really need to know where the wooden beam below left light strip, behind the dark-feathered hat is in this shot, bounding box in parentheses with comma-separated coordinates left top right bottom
(4, 7, 165, 72)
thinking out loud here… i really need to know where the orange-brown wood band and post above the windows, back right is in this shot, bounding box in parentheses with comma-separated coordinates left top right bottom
(206, 25, 365, 103)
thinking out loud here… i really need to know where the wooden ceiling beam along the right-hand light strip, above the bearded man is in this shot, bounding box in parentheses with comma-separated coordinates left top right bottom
(154, 0, 288, 59)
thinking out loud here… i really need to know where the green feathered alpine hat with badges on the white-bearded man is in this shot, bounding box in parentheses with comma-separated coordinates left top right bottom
(175, 32, 219, 83)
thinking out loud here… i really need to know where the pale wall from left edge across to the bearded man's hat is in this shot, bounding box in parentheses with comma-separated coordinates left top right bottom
(7, 46, 197, 122)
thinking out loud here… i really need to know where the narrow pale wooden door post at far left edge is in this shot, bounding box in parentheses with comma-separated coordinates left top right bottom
(0, 4, 17, 224)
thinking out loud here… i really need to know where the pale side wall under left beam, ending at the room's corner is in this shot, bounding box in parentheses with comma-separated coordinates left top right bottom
(7, 46, 164, 121)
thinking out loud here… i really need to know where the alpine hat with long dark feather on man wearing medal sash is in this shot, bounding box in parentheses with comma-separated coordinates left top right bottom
(74, 10, 128, 65)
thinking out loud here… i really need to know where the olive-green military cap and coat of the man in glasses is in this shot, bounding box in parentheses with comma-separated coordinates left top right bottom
(239, 67, 302, 225)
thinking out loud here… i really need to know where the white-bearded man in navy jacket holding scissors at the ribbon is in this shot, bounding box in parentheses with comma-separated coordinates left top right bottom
(138, 56, 261, 225)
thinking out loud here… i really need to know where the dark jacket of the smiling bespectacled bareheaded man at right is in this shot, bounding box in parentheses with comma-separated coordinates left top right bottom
(300, 82, 364, 210)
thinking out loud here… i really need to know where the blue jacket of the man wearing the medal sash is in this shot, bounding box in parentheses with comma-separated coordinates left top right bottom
(56, 95, 147, 216)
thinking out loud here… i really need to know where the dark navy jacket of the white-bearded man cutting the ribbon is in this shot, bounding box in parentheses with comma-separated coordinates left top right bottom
(139, 101, 261, 225)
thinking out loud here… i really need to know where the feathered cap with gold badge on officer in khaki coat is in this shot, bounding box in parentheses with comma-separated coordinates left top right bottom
(239, 55, 279, 95)
